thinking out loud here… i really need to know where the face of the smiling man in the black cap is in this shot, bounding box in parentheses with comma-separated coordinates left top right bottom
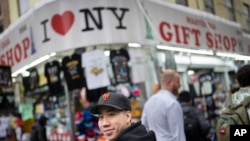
(98, 106, 131, 141)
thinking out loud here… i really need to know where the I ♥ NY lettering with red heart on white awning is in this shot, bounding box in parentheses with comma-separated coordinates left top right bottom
(37, 4, 136, 48)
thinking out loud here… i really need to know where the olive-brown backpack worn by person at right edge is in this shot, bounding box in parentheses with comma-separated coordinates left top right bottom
(216, 94, 250, 141)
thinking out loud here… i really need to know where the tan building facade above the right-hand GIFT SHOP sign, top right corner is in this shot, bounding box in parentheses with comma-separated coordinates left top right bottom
(166, 0, 250, 33)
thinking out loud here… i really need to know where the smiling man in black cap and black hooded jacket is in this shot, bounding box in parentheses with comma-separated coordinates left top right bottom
(90, 92, 156, 141)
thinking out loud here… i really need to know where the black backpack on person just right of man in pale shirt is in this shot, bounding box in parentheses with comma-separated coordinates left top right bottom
(183, 110, 201, 141)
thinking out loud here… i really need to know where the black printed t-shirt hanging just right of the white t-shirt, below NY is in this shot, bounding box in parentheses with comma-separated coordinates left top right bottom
(110, 49, 131, 84)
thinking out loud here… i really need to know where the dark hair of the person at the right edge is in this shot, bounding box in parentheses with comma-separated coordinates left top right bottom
(236, 64, 250, 87)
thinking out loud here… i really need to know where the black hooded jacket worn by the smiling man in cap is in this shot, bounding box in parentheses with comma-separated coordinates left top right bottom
(116, 122, 156, 141)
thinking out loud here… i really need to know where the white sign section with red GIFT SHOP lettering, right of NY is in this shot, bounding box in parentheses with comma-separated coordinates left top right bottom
(144, 2, 242, 53)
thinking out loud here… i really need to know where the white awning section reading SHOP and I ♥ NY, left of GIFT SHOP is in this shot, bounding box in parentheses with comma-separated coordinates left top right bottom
(0, 0, 144, 71)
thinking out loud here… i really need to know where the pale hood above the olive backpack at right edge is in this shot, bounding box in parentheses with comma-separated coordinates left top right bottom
(231, 87, 250, 107)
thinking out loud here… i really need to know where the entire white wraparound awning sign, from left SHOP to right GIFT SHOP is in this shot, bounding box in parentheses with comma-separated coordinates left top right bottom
(0, 0, 246, 72)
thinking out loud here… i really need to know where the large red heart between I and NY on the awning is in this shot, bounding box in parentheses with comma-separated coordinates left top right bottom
(51, 11, 75, 35)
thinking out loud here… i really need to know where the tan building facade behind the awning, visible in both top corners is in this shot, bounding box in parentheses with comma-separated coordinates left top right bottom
(0, 0, 250, 33)
